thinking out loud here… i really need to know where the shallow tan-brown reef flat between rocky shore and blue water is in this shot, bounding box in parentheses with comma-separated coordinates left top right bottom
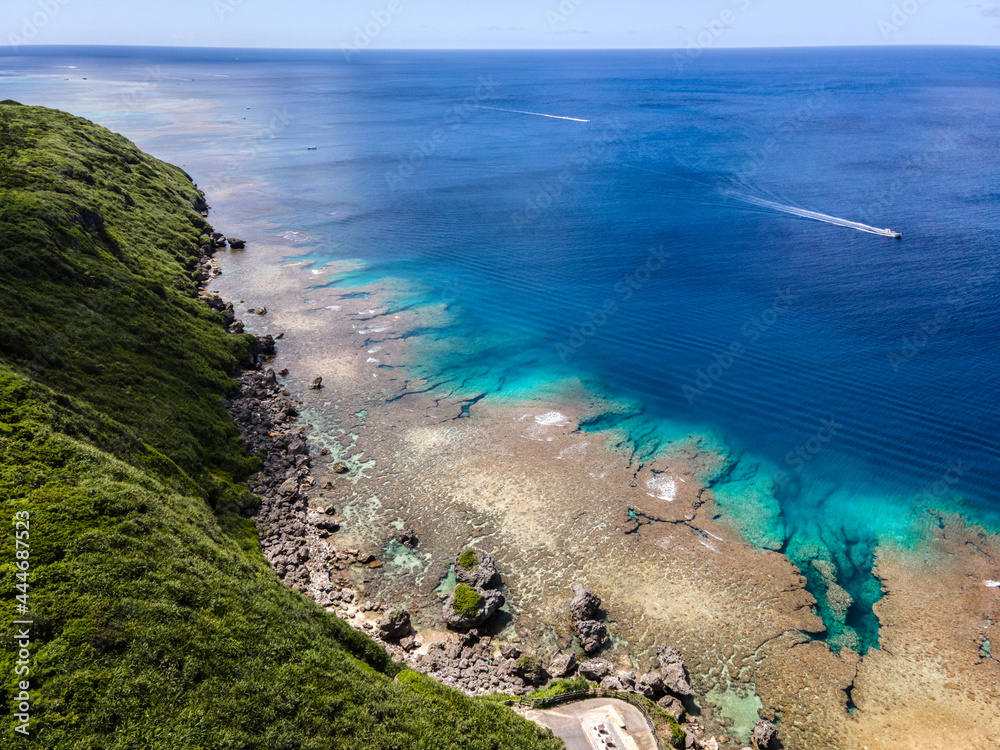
(214, 242, 1000, 750)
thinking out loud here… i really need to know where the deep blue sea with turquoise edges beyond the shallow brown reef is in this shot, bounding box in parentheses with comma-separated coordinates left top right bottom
(0, 48, 1000, 648)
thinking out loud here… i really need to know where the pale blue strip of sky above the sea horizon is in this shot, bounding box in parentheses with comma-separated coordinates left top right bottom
(0, 0, 1000, 49)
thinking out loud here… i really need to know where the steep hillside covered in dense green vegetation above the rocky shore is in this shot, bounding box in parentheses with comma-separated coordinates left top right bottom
(0, 103, 561, 750)
